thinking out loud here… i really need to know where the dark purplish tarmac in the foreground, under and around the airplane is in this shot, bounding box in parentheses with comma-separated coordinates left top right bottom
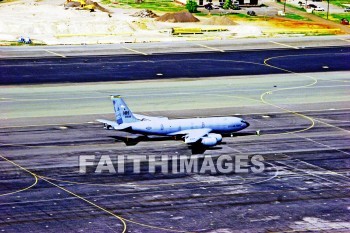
(0, 110, 350, 232)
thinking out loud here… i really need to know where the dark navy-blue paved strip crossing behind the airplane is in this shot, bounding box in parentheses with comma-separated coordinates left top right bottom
(0, 46, 350, 85)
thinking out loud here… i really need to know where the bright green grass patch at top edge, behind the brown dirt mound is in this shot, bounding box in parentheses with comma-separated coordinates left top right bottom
(101, 0, 186, 12)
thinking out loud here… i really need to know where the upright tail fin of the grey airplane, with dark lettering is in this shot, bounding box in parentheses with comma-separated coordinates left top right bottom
(111, 95, 139, 125)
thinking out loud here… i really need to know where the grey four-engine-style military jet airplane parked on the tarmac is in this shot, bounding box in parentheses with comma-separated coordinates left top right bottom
(97, 95, 249, 152)
